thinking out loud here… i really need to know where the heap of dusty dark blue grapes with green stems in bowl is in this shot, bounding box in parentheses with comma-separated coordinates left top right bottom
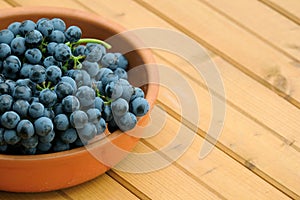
(0, 18, 149, 155)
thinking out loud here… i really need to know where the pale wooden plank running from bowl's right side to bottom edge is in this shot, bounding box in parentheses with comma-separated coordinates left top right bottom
(138, 109, 287, 199)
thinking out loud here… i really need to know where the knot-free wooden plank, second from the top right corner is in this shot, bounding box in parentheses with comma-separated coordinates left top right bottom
(202, 0, 300, 60)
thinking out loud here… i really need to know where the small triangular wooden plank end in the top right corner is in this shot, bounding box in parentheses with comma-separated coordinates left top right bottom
(259, 0, 300, 24)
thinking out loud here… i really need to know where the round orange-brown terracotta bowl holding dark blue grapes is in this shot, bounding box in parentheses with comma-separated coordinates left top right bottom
(0, 7, 158, 192)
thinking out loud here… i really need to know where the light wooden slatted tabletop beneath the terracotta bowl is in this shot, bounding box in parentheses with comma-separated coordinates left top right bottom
(0, 0, 300, 200)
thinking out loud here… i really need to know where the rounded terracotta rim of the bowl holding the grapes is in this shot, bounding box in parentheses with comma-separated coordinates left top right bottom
(0, 6, 159, 161)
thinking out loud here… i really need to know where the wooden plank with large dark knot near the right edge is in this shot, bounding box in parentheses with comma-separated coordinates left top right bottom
(137, 0, 300, 107)
